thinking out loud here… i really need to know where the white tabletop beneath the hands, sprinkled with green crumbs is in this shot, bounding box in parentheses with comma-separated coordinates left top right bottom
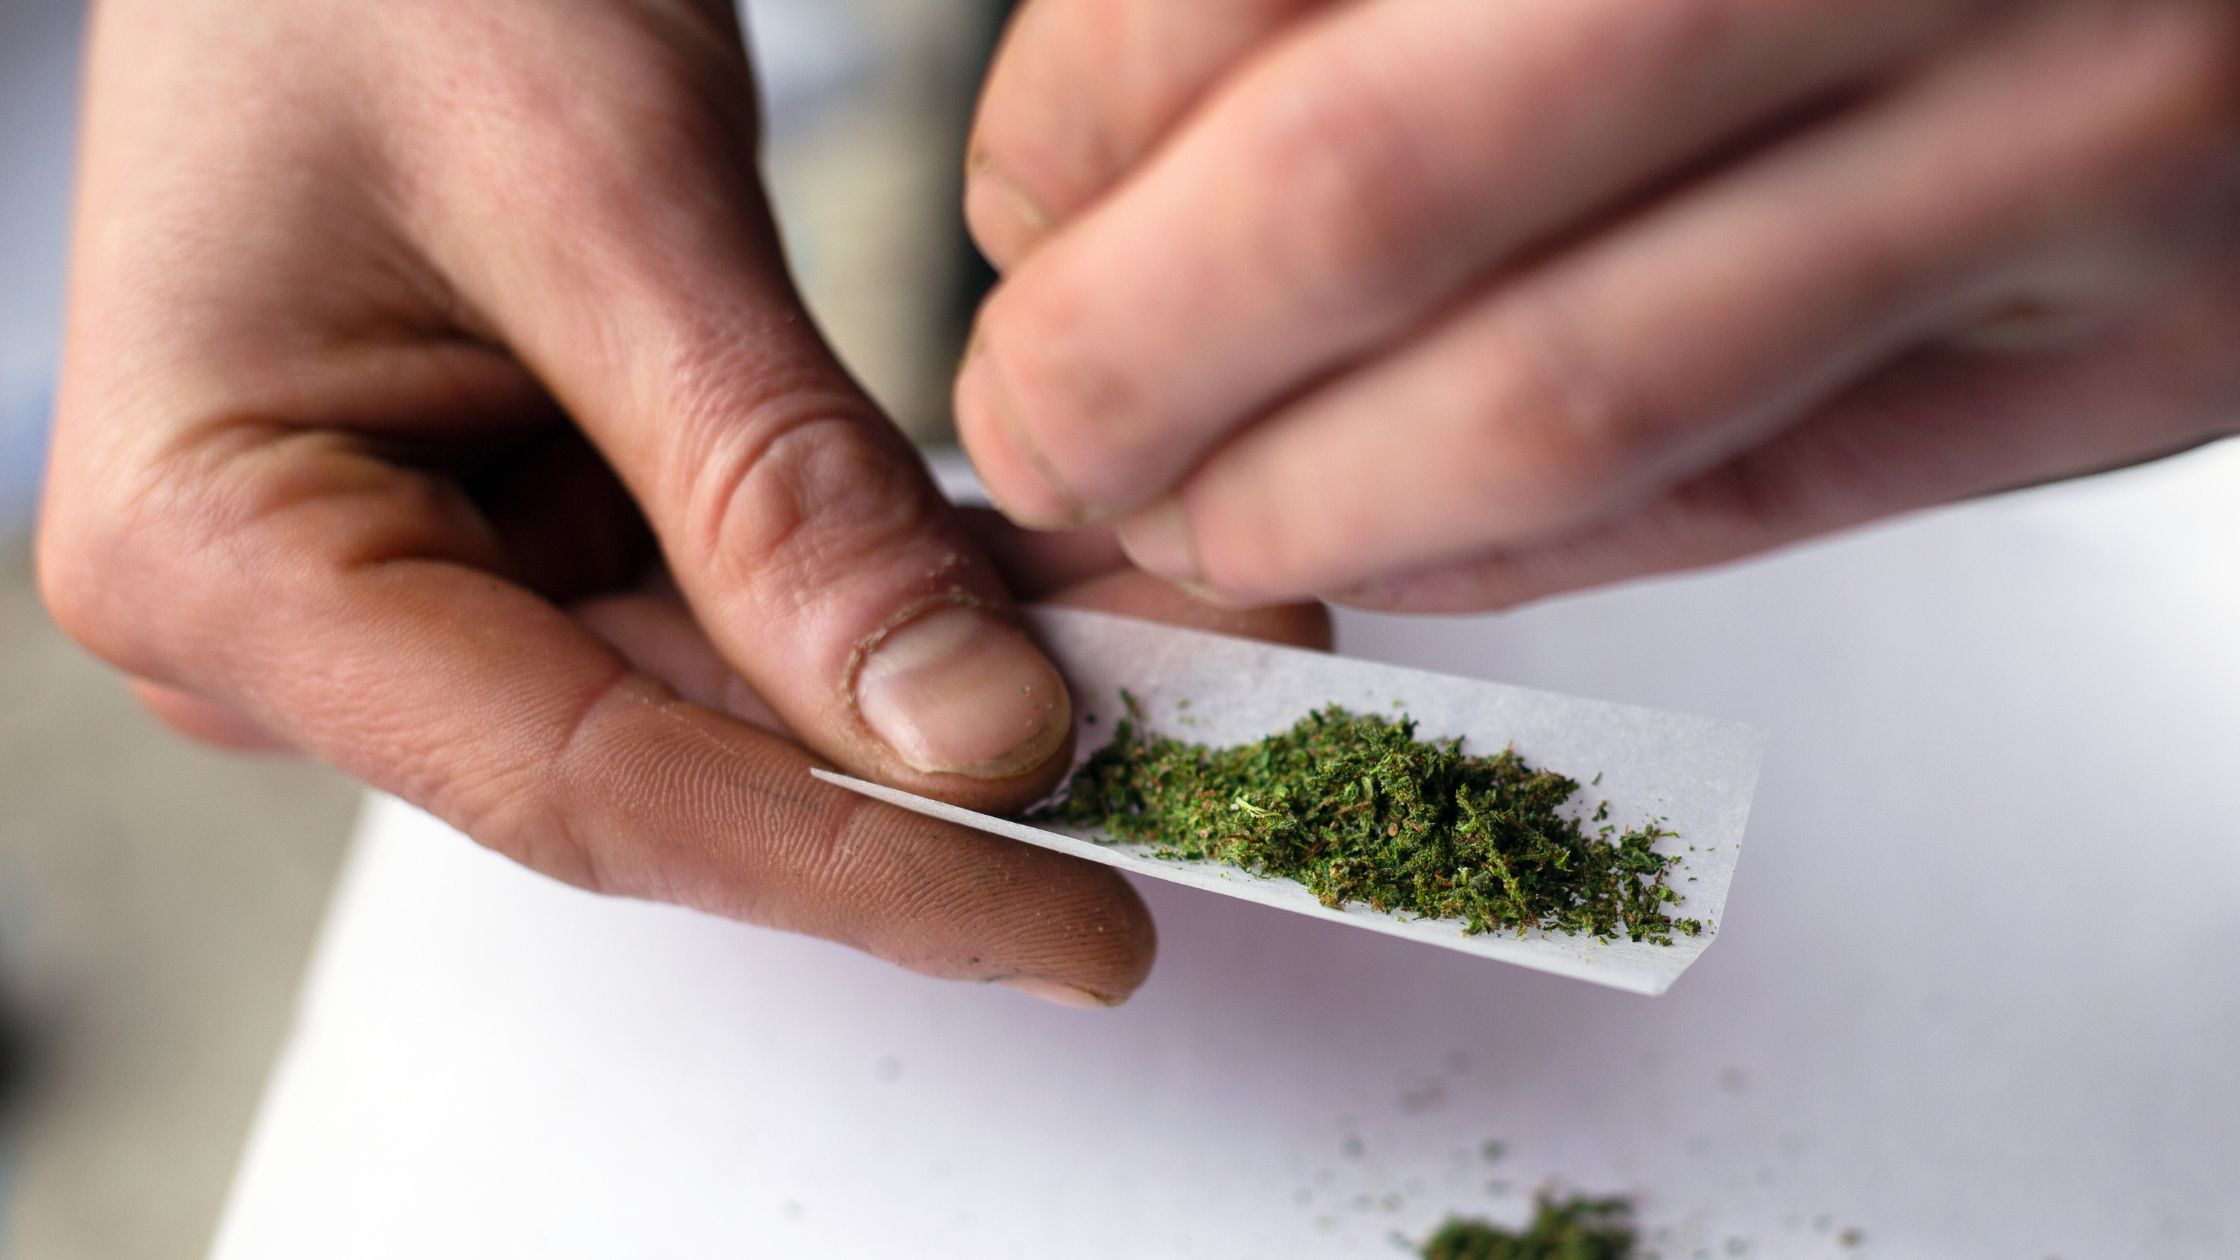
(215, 446, 2240, 1260)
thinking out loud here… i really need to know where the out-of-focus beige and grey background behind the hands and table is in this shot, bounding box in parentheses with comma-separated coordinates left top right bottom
(0, 0, 1006, 1260)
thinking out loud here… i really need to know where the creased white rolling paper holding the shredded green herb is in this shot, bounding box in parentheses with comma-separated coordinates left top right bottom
(815, 608, 1765, 995)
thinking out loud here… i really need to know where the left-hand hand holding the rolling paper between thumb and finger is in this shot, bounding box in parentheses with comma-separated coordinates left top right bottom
(40, 0, 1317, 1002)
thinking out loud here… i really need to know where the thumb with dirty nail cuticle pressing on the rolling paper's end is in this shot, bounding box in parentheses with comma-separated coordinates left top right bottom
(430, 51, 1073, 809)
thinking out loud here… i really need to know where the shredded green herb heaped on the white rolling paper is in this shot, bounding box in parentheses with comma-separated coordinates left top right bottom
(1037, 697, 1702, 944)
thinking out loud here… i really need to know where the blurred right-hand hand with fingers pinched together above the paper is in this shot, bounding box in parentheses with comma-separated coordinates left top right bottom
(956, 0, 2240, 610)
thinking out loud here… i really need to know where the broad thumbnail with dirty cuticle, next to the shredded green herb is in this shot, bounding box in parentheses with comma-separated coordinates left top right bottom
(856, 608, 1073, 778)
